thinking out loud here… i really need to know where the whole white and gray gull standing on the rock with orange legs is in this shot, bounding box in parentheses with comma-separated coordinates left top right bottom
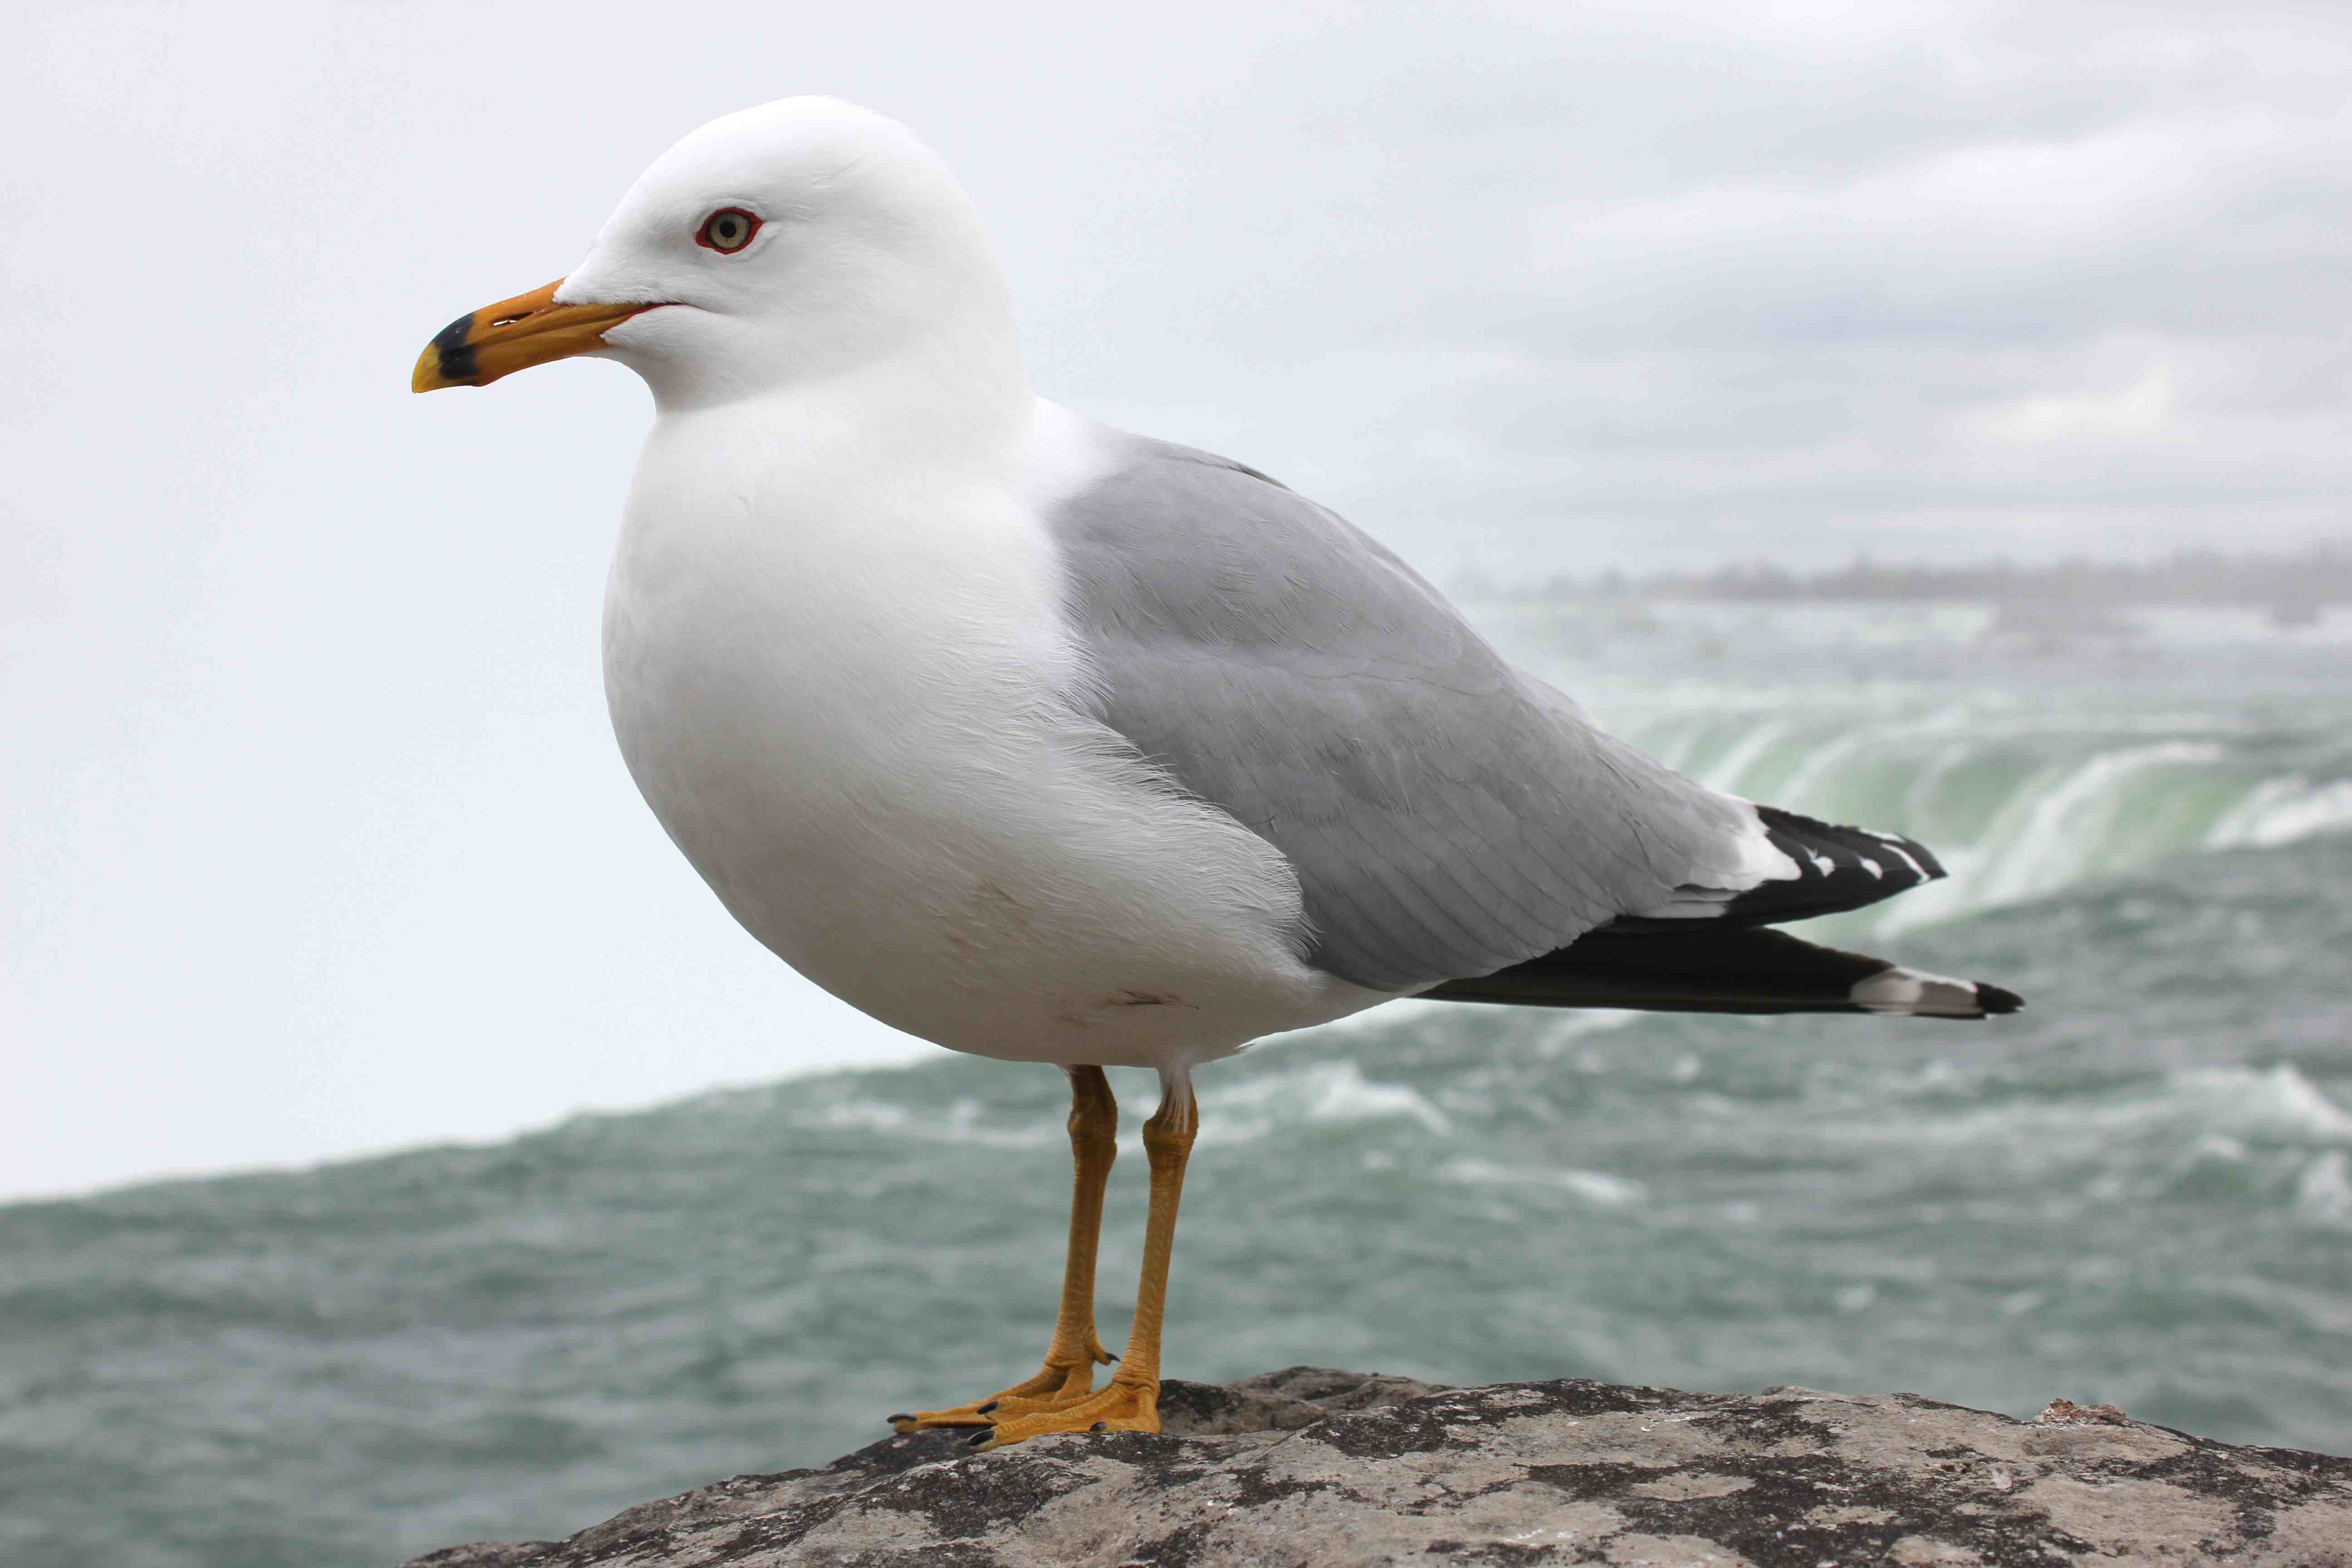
(412, 96, 2020, 1448)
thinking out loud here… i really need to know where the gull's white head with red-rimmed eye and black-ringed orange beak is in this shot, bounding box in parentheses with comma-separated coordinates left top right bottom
(412, 99, 1021, 409)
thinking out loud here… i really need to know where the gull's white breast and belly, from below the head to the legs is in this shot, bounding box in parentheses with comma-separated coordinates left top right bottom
(604, 404, 1381, 1065)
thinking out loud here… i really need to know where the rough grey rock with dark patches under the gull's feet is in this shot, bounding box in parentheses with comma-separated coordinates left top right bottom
(409, 1366, 2352, 1568)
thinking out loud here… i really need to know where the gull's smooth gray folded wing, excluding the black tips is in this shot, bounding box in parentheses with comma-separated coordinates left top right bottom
(1049, 435, 1759, 990)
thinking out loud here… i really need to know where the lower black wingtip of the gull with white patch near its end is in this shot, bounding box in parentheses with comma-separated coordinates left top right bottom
(1421, 921, 2025, 1018)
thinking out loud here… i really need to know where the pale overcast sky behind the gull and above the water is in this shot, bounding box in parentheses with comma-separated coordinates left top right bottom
(0, 0, 2352, 1194)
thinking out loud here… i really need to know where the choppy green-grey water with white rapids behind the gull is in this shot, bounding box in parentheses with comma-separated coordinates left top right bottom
(0, 604, 2352, 1568)
